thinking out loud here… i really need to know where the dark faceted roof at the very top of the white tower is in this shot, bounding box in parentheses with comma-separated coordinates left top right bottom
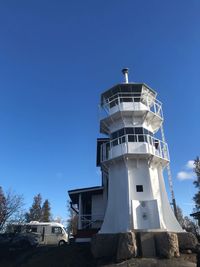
(101, 83, 157, 103)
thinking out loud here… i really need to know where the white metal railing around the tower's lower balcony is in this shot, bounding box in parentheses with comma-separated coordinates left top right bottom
(101, 134, 169, 162)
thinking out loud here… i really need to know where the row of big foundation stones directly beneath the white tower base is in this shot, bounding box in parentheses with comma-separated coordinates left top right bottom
(91, 232, 184, 262)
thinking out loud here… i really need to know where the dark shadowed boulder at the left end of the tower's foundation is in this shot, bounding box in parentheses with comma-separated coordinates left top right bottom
(91, 234, 119, 259)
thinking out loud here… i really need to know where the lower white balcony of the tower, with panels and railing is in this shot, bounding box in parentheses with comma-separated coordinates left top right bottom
(101, 134, 169, 163)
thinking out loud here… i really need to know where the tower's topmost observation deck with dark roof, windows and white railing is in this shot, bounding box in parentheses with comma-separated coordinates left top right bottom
(100, 83, 163, 134)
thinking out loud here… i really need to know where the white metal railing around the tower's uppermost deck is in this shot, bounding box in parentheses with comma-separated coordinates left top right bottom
(101, 93, 163, 118)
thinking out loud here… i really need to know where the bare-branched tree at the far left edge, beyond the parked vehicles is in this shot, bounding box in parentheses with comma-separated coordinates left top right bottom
(0, 186, 24, 231)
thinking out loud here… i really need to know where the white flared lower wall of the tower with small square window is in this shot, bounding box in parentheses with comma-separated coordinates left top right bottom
(100, 158, 183, 233)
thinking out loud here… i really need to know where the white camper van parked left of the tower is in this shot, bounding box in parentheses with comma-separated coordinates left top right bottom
(8, 221, 69, 246)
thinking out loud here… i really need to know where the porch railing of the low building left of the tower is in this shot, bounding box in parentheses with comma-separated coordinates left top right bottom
(79, 214, 104, 229)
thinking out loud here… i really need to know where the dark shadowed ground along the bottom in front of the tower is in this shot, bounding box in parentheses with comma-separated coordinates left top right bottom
(0, 244, 196, 267)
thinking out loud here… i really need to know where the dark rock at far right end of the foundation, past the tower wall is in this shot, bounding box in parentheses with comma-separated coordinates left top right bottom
(177, 232, 198, 251)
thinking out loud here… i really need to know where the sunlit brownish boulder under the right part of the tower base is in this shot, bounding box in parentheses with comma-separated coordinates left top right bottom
(155, 232, 180, 259)
